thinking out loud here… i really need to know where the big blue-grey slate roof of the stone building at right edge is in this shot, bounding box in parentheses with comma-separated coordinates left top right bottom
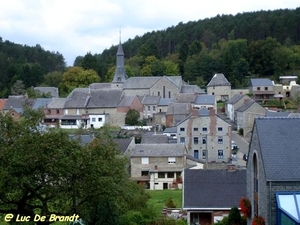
(250, 117, 300, 181)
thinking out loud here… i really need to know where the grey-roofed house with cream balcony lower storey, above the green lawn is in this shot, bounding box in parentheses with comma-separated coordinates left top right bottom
(130, 144, 186, 190)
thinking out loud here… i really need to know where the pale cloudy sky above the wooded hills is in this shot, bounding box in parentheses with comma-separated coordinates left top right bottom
(0, 0, 300, 66)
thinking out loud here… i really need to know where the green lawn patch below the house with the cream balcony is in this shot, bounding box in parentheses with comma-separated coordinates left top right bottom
(147, 189, 182, 214)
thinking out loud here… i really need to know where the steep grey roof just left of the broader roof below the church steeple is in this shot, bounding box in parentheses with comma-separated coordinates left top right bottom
(64, 88, 90, 109)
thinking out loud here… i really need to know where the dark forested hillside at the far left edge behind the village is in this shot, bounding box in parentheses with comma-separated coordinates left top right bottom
(0, 37, 66, 97)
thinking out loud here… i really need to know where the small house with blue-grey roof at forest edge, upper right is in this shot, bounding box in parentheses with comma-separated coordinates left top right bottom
(249, 78, 275, 101)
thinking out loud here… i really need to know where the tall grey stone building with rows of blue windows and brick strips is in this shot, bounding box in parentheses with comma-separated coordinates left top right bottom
(176, 108, 231, 163)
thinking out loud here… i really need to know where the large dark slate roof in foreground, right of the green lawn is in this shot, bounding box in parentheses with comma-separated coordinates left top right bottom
(183, 169, 247, 209)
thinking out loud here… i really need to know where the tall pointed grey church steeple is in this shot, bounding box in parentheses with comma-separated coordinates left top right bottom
(112, 31, 127, 83)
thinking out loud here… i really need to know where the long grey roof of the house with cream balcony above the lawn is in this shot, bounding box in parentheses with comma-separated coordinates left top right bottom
(131, 144, 185, 157)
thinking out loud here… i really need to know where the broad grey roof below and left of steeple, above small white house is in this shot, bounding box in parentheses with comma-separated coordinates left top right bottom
(87, 89, 122, 108)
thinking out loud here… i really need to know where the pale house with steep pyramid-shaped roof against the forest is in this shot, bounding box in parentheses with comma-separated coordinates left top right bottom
(206, 73, 231, 102)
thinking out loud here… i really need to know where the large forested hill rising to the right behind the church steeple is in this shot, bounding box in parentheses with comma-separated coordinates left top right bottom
(84, 8, 300, 86)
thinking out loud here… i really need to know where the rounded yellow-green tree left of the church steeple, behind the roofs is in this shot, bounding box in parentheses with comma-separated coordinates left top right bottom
(62, 67, 100, 92)
